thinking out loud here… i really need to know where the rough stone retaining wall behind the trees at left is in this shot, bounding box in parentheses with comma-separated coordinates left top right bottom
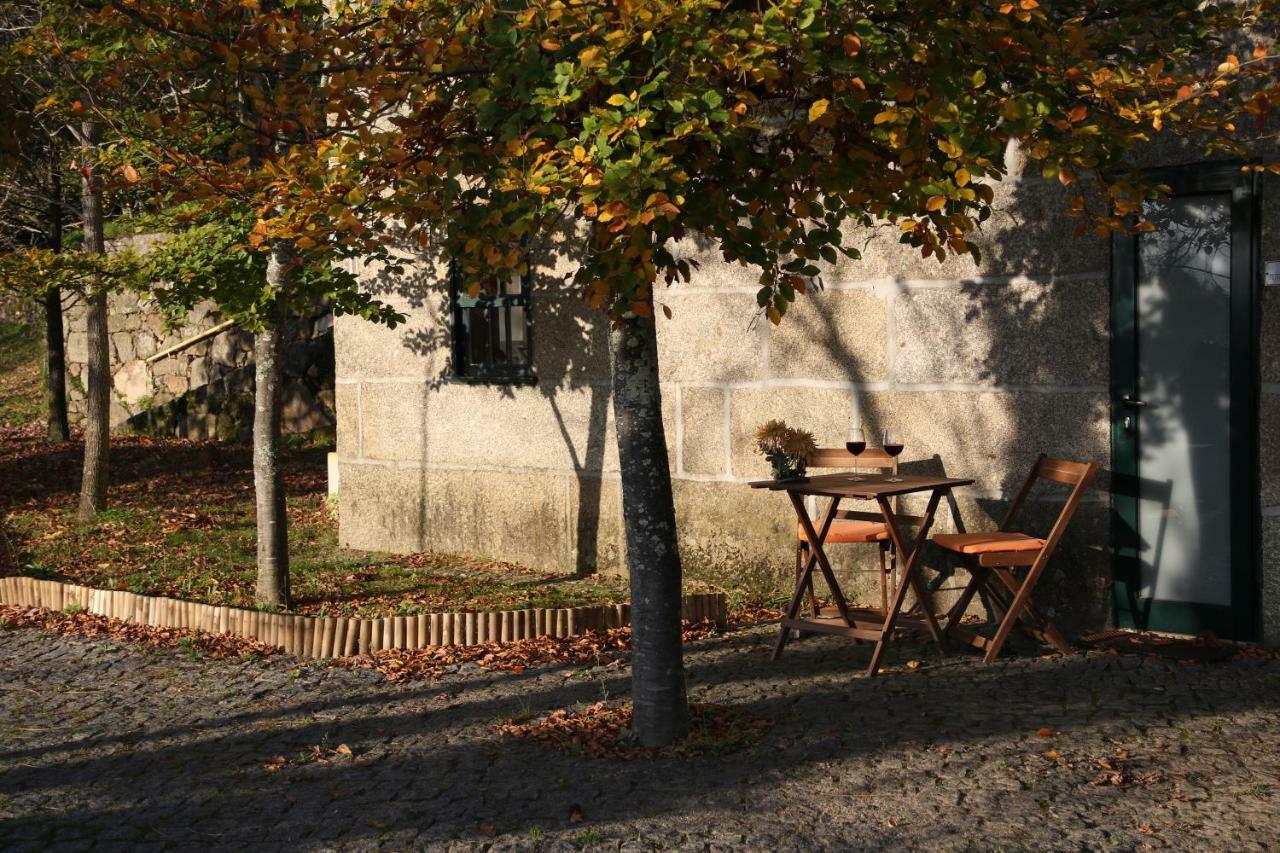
(64, 234, 334, 439)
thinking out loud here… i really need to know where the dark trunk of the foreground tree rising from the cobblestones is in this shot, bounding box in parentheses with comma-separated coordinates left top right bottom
(609, 308, 689, 747)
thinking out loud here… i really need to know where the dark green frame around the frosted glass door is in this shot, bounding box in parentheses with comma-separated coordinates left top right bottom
(1110, 161, 1262, 639)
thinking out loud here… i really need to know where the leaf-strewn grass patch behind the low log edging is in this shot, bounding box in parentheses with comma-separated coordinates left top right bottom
(0, 430, 727, 616)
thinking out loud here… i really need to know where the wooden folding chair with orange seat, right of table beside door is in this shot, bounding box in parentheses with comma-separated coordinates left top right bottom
(933, 453, 1098, 663)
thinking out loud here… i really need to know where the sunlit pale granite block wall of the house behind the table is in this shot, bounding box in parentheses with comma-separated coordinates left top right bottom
(335, 146, 1280, 639)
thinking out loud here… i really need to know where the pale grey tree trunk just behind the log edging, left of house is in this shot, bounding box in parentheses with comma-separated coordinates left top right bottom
(253, 257, 292, 607)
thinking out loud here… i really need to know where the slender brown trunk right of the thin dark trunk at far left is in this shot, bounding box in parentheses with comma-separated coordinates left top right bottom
(76, 122, 111, 521)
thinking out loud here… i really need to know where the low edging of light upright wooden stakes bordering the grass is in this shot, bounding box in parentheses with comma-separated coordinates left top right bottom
(0, 576, 728, 658)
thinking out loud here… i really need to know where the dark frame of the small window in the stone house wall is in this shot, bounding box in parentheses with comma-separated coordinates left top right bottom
(449, 264, 538, 386)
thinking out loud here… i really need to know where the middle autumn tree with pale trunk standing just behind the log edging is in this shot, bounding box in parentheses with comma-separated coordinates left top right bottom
(8, 0, 398, 607)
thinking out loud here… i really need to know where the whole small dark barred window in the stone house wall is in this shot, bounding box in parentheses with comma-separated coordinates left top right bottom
(449, 266, 536, 384)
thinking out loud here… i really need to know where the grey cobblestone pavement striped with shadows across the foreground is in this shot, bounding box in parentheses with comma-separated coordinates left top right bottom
(0, 617, 1280, 850)
